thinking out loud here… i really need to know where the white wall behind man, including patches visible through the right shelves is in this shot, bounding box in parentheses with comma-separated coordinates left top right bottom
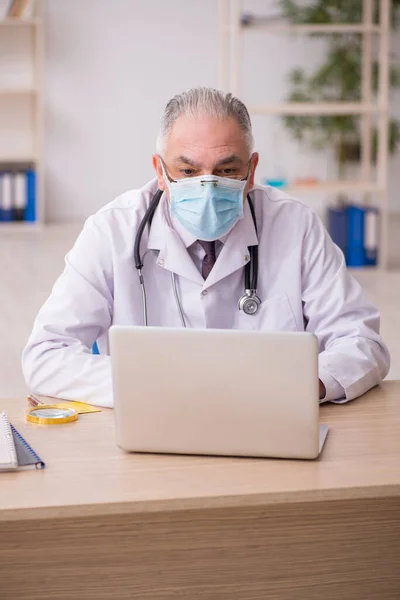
(45, 0, 400, 221)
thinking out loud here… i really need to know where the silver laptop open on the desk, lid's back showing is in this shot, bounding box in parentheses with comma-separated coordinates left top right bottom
(110, 326, 328, 458)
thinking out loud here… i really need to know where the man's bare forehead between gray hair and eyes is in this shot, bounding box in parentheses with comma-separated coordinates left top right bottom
(166, 115, 248, 159)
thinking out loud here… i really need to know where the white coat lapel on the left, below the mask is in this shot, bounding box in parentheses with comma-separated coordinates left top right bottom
(147, 195, 204, 286)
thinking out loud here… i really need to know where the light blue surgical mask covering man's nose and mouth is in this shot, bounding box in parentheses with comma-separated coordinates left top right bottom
(163, 166, 246, 241)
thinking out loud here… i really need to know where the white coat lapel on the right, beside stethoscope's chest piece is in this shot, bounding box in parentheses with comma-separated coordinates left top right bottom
(204, 200, 258, 289)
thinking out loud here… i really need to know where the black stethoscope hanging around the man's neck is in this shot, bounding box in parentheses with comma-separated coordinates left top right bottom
(133, 190, 261, 327)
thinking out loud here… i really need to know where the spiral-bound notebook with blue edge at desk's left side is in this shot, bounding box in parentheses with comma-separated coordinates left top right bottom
(0, 413, 45, 471)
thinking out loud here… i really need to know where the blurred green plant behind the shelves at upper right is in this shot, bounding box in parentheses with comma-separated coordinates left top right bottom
(281, 0, 400, 179)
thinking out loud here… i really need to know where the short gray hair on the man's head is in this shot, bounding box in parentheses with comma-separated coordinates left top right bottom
(156, 87, 254, 155)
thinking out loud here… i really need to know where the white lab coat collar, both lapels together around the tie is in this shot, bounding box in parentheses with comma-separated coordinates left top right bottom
(147, 194, 258, 289)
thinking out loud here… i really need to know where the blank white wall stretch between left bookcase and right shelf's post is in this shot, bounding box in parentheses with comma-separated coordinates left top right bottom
(45, 0, 218, 221)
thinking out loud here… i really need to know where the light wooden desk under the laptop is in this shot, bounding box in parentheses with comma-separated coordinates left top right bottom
(0, 381, 400, 600)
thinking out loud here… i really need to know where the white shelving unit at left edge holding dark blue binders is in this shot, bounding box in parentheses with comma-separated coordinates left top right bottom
(0, 0, 45, 234)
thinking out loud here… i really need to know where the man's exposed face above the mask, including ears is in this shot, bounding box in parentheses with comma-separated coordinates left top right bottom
(153, 115, 258, 198)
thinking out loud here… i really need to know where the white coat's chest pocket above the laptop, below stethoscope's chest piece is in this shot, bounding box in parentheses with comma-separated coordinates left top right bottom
(235, 293, 299, 332)
